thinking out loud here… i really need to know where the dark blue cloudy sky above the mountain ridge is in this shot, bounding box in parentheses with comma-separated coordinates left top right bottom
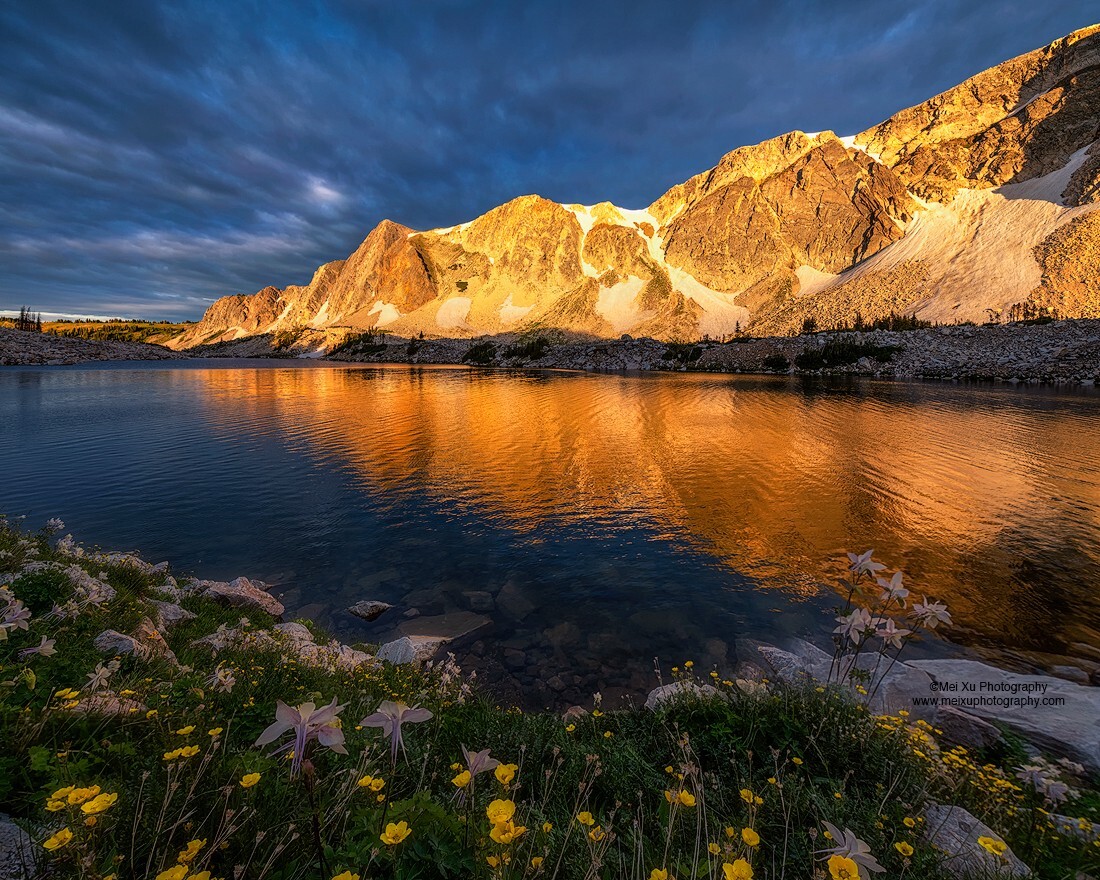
(0, 0, 1097, 318)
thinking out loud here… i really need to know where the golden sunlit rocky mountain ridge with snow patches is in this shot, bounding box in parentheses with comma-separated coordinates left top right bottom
(173, 25, 1100, 348)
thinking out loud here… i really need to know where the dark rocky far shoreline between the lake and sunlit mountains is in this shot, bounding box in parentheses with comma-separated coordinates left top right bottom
(0, 319, 1100, 386)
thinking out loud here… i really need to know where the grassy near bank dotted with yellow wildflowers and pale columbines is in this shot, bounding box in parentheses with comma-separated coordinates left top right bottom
(0, 524, 1100, 880)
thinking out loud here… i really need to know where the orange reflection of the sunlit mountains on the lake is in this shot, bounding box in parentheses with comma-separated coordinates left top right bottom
(194, 367, 1100, 644)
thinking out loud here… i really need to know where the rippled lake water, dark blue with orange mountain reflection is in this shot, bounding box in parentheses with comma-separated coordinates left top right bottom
(0, 361, 1100, 703)
